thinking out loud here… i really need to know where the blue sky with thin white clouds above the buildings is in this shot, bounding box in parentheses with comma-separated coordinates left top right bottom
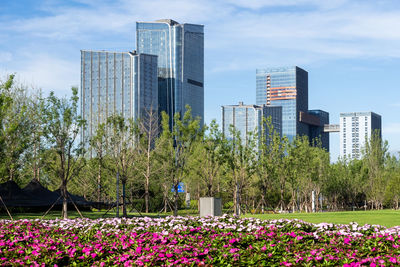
(0, 0, 400, 161)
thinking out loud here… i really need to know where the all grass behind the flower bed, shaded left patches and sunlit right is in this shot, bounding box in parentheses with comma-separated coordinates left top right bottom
(0, 210, 400, 227)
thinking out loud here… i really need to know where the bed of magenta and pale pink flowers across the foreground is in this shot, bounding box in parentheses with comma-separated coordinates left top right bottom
(0, 215, 400, 266)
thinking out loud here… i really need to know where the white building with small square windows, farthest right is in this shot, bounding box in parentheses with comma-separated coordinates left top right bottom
(340, 112, 382, 159)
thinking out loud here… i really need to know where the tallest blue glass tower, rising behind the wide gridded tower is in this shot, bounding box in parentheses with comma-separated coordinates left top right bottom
(136, 19, 204, 125)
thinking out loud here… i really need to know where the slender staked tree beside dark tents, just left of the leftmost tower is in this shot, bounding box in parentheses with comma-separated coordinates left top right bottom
(43, 87, 85, 219)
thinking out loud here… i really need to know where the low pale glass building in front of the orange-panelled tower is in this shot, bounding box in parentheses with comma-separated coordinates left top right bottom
(222, 102, 282, 147)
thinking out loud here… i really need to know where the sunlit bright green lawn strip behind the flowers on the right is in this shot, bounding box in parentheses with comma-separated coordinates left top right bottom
(245, 210, 400, 227)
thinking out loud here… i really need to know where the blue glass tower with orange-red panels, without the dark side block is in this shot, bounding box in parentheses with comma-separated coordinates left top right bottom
(256, 66, 309, 141)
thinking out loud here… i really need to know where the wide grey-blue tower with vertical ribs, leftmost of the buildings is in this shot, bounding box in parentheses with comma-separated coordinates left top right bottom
(81, 50, 158, 147)
